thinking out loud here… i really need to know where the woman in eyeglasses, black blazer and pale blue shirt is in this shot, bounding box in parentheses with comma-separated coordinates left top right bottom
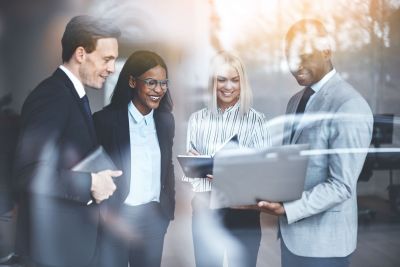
(94, 51, 175, 267)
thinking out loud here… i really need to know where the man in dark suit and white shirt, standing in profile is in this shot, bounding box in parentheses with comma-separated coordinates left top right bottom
(14, 16, 122, 267)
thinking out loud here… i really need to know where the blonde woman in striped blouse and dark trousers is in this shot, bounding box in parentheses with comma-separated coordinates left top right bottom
(183, 52, 270, 267)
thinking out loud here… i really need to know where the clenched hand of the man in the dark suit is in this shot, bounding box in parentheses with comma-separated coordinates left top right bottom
(90, 170, 122, 204)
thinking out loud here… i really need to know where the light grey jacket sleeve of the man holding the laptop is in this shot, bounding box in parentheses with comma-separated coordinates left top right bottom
(283, 99, 373, 224)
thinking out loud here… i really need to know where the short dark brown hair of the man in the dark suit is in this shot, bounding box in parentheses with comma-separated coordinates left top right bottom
(61, 15, 121, 62)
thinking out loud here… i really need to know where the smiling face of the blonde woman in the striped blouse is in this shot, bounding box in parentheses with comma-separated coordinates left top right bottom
(215, 64, 240, 110)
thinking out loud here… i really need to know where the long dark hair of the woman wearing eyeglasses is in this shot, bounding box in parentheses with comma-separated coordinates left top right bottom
(110, 50, 173, 111)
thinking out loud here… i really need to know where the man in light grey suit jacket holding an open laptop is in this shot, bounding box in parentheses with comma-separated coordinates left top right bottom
(258, 19, 373, 267)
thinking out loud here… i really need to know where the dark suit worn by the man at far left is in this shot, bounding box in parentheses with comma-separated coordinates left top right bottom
(14, 69, 99, 266)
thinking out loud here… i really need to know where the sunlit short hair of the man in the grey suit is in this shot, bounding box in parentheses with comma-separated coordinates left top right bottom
(285, 19, 328, 45)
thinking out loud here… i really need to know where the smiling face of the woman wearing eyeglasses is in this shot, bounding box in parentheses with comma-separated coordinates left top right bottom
(129, 65, 167, 115)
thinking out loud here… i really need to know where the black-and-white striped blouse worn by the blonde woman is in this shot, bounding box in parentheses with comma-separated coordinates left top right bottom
(182, 103, 271, 192)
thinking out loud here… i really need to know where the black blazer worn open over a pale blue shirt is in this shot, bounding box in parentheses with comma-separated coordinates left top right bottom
(93, 105, 175, 220)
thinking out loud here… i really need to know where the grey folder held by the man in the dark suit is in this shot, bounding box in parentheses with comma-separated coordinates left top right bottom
(72, 146, 118, 173)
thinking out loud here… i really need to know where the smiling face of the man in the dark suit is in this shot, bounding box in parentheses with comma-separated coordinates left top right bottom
(79, 38, 118, 89)
